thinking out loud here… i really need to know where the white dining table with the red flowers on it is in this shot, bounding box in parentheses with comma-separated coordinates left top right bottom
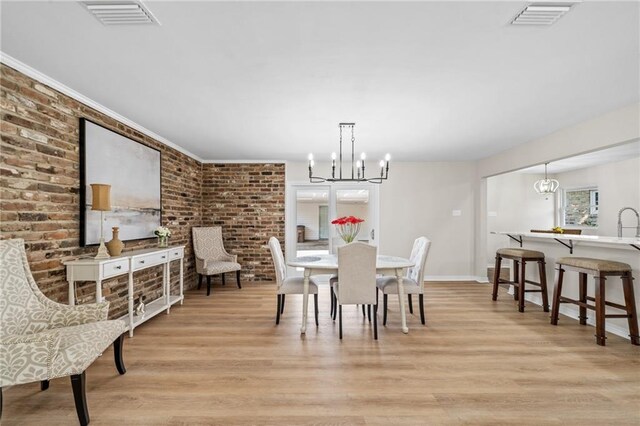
(287, 254, 415, 334)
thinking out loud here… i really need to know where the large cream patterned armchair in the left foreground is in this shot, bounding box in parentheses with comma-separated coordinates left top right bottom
(0, 239, 126, 425)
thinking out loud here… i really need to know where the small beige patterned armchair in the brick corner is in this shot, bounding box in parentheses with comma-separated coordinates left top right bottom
(192, 226, 242, 296)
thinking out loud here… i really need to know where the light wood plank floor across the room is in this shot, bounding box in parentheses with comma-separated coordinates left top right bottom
(2, 283, 640, 426)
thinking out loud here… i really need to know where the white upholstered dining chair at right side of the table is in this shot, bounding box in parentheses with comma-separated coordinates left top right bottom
(376, 237, 431, 325)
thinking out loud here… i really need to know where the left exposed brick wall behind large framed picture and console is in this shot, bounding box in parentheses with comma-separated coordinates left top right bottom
(0, 65, 202, 317)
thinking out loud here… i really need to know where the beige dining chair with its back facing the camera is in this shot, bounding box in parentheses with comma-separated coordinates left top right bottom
(333, 243, 378, 340)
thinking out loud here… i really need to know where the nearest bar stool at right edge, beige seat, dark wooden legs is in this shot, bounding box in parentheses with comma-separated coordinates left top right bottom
(551, 257, 640, 346)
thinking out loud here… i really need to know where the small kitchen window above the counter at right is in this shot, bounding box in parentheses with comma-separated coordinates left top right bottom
(562, 187, 600, 228)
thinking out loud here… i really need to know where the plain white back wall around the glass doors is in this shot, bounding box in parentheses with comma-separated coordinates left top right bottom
(286, 162, 478, 279)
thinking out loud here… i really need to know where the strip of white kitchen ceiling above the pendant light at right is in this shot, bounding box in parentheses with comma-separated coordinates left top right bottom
(515, 140, 640, 174)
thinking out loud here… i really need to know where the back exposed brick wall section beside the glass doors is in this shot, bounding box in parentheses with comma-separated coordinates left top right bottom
(202, 164, 285, 281)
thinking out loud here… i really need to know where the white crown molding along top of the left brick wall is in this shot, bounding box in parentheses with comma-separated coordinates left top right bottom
(0, 51, 202, 163)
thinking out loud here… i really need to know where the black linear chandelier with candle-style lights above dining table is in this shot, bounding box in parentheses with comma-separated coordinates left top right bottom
(309, 123, 391, 184)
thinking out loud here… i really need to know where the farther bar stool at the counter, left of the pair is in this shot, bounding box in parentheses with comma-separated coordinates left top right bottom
(492, 248, 549, 312)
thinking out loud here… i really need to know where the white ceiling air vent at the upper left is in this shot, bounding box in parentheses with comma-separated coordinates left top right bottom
(81, 0, 160, 25)
